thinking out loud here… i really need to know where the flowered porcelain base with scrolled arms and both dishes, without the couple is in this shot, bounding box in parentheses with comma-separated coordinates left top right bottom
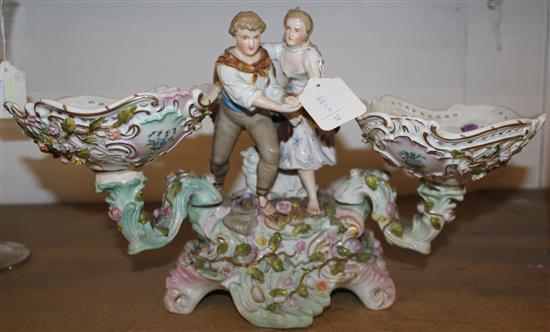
(4, 86, 545, 328)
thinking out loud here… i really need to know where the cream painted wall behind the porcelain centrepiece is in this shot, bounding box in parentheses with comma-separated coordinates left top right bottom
(0, 0, 550, 204)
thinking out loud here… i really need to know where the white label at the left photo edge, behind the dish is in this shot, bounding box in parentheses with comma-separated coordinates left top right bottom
(0, 61, 27, 118)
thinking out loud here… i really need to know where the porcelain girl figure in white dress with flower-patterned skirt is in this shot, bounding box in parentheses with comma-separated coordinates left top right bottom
(264, 8, 336, 214)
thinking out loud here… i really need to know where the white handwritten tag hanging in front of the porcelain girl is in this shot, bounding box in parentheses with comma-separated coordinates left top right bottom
(299, 78, 367, 131)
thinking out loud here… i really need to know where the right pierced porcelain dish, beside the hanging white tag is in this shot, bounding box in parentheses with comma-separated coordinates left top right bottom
(357, 96, 545, 185)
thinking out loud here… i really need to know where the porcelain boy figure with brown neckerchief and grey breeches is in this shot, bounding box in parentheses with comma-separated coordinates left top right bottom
(210, 12, 300, 234)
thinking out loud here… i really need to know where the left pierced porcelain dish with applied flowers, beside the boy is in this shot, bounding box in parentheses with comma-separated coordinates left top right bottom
(4, 89, 216, 172)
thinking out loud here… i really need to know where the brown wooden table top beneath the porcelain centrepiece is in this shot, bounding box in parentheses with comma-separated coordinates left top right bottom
(0, 190, 550, 331)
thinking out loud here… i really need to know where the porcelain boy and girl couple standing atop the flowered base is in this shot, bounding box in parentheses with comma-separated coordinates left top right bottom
(210, 8, 336, 234)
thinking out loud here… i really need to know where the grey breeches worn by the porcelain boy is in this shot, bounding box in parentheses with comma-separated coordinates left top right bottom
(210, 103, 279, 196)
